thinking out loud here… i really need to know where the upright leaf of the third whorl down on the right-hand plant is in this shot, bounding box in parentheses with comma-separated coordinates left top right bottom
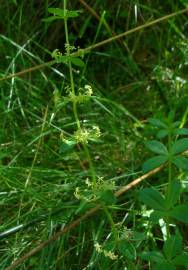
(166, 180, 182, 209)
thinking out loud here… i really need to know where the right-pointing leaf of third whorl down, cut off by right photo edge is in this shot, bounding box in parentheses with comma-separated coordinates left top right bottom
(169, 204, 188, 223)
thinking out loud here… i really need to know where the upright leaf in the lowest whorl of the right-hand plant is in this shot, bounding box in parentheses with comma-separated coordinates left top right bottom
(163, 233, 182, 260)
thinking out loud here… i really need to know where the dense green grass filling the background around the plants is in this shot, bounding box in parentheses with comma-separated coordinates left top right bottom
(0, 0, 188, 270)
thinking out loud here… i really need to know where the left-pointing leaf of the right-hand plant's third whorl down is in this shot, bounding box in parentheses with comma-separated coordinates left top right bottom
(139, 188, 165, 211)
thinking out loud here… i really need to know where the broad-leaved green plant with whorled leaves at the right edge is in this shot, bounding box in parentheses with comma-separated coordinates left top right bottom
(139, 112, 188, 269)
